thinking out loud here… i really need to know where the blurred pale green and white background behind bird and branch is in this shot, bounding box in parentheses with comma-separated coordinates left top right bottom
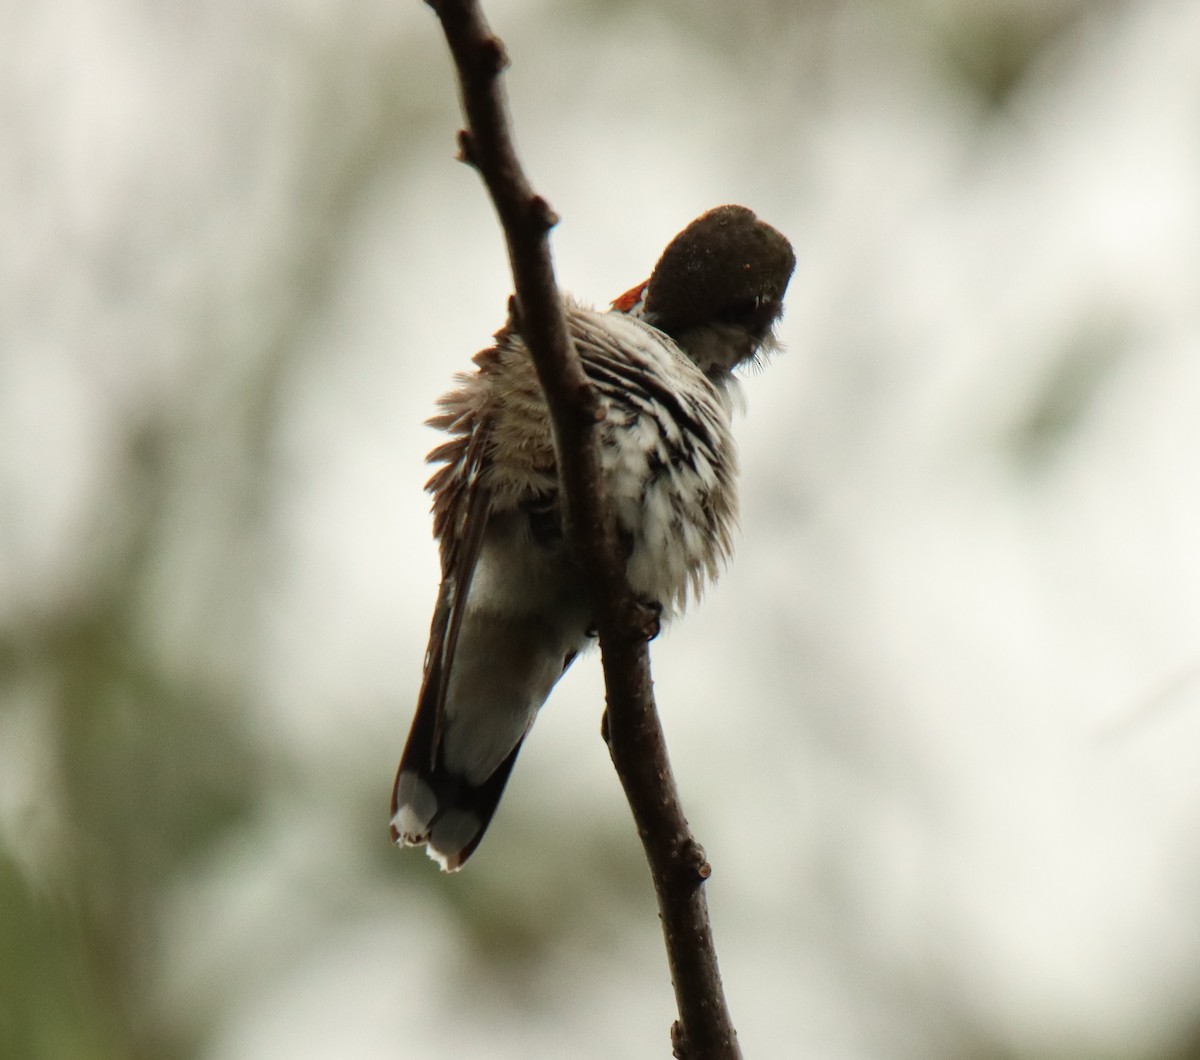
(7, 0, 1200, 1060)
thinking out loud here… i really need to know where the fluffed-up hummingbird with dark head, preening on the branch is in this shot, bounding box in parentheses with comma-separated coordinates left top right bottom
(391, 205, 796, 872)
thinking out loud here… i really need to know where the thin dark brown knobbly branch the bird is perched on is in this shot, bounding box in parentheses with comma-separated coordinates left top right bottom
(428, 0, 742, 1060)
